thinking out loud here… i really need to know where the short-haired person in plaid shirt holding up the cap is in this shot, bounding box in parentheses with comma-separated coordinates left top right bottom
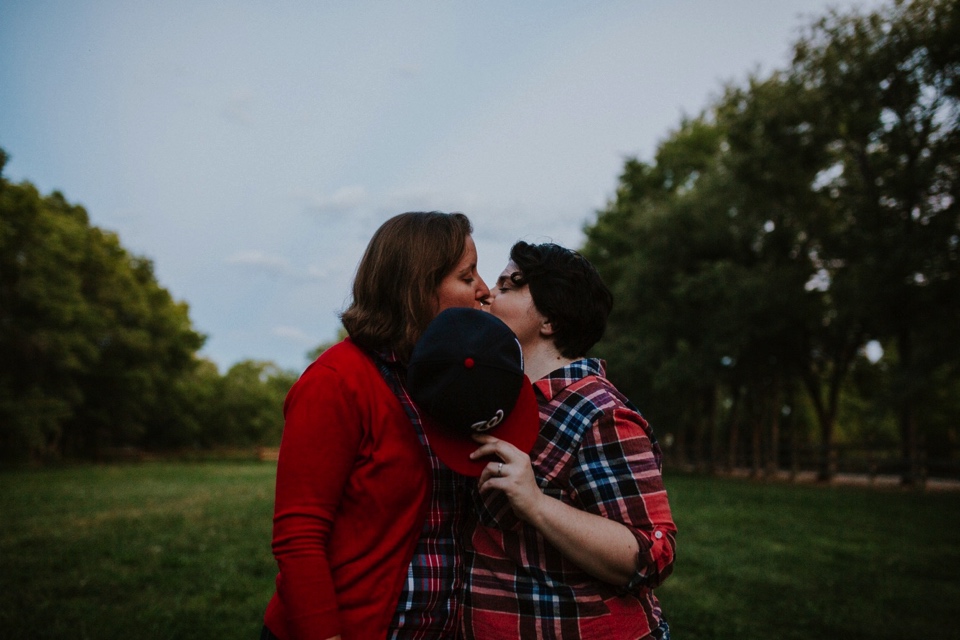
(463, 242, 677, 640)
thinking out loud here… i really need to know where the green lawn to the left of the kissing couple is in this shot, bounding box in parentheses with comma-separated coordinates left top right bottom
(0, 463, 276, 640)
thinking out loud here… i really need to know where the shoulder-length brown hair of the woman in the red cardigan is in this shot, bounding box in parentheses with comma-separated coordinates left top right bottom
(340, 211, 473, 361)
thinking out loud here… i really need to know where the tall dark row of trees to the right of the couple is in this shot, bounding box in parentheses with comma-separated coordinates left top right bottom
(583, 0, 960, 483)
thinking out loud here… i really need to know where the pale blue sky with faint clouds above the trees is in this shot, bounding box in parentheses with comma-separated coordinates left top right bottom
(0, 0, 880, 372)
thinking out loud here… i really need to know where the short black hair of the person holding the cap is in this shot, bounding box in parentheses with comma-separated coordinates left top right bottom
(510, 241, 613, 358)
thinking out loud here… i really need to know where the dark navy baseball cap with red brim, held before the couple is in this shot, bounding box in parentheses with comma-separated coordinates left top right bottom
(407, 308, 540, 476)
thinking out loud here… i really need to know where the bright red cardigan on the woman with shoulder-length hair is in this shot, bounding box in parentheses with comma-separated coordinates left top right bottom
(264, 338, 431, 640)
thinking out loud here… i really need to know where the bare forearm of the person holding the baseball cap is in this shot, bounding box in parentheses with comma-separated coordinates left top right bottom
(517, 494, 639, 587)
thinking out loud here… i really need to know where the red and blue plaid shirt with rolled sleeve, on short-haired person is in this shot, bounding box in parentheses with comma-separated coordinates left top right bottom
(463, 359, 676, 640)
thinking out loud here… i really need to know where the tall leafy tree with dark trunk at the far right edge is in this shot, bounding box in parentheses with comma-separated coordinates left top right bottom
(790, 0, 960, 483)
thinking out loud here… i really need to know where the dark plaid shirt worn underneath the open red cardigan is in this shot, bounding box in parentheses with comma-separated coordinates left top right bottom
(374, 352, 467, 640)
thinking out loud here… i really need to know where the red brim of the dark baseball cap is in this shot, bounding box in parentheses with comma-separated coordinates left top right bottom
(423, 376, 540, 478)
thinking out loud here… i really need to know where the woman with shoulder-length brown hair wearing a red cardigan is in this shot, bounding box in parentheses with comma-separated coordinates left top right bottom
(261, 212, 490, 640)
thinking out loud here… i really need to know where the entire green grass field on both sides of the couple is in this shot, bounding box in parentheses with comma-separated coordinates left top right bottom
(0, 462, 960, 640)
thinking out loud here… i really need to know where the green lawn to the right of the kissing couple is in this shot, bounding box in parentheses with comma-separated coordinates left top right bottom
(658, 476, 960, 640)
